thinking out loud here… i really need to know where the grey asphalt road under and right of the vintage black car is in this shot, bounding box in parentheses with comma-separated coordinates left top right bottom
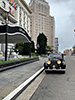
(30, 57, 75, 100)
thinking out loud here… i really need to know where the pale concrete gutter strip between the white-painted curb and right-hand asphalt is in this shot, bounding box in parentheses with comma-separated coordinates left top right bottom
(16, 72, 46, 100)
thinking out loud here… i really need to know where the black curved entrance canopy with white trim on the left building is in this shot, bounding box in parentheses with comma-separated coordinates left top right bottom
(0, 25, 31, 43)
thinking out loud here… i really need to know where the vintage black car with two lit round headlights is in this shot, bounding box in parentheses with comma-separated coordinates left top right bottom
(44, 54, 66, 73)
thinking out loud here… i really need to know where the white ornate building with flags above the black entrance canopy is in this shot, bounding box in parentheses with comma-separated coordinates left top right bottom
(0, 0, 31, 53)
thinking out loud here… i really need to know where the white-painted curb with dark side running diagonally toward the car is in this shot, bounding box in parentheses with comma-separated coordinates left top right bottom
(3, 67, 44, 100)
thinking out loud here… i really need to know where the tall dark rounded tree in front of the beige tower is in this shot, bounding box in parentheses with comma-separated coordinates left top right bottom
(37, 33, 47, 54)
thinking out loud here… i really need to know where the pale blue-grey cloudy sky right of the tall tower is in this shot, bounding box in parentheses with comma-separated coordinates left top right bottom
(26, 0, 75, 51)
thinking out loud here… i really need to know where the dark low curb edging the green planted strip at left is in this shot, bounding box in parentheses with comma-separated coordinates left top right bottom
(0, 59, 39, 72)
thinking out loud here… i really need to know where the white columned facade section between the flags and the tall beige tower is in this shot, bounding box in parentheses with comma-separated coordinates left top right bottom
(16, 0, 31, 36)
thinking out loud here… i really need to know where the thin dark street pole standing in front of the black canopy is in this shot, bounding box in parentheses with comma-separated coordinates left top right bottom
(5, 12, 9, 61)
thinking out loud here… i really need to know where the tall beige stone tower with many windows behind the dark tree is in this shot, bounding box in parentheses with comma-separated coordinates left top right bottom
(30, 0, 55, 47)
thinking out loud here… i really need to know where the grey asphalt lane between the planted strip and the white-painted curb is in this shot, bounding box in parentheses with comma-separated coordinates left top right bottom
(0, 58, 45, 100)
